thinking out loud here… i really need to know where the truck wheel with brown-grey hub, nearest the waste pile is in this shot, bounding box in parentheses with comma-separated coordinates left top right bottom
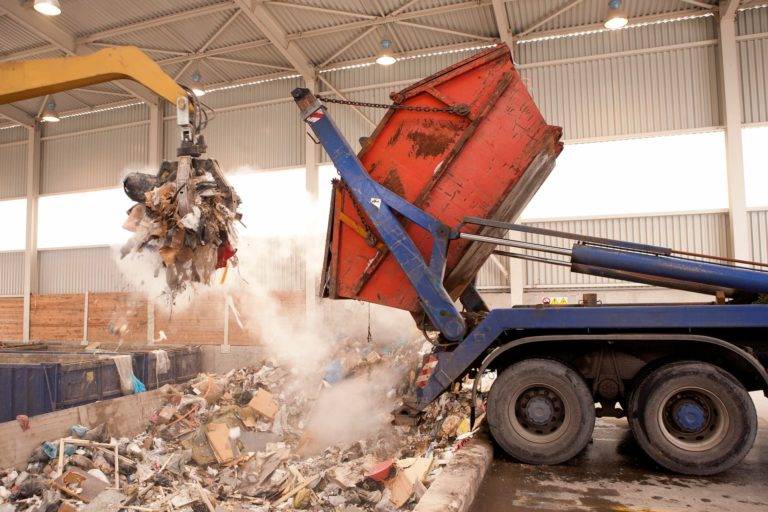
(488, 359, 595, 464)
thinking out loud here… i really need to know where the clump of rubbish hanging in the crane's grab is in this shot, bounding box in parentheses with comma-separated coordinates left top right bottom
(121, 157, 242, 294)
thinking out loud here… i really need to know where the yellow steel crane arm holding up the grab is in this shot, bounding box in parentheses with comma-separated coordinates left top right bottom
(0, 46, 187, 105)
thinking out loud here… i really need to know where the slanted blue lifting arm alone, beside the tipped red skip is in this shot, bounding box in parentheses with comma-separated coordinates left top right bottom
(291, 88, 466, 341)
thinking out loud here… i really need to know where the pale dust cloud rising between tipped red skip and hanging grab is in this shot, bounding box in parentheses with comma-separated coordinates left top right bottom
(115, 165, 420, 450)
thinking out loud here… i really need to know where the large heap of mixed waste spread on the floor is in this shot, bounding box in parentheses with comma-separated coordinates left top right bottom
(0, 338, 474, 512)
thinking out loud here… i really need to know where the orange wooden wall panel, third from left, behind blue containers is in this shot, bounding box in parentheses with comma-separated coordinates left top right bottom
(88, 293, 147, 344)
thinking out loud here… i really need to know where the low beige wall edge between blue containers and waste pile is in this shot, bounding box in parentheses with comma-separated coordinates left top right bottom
(0, 390, 164, 469)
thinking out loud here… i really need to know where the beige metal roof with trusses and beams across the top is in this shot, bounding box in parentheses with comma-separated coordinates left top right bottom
(0, 0, 748, 126)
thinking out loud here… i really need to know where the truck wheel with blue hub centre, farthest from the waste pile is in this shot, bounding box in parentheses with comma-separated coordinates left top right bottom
(627, 361, 757, 475)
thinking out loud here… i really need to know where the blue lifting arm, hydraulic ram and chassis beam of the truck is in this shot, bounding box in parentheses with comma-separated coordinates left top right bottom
(292, 89, 768, 411)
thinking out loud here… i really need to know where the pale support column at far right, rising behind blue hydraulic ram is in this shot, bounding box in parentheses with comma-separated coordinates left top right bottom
(719, 0, 751, 259)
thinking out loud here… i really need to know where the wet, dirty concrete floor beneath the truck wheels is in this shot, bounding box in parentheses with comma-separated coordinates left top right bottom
(471, 398, 768, 512)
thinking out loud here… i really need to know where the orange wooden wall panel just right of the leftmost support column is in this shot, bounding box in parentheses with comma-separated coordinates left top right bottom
(29, 293, 85, 343)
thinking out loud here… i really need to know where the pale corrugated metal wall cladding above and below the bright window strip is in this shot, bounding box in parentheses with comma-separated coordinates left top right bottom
(13, 9, 768, 293)
